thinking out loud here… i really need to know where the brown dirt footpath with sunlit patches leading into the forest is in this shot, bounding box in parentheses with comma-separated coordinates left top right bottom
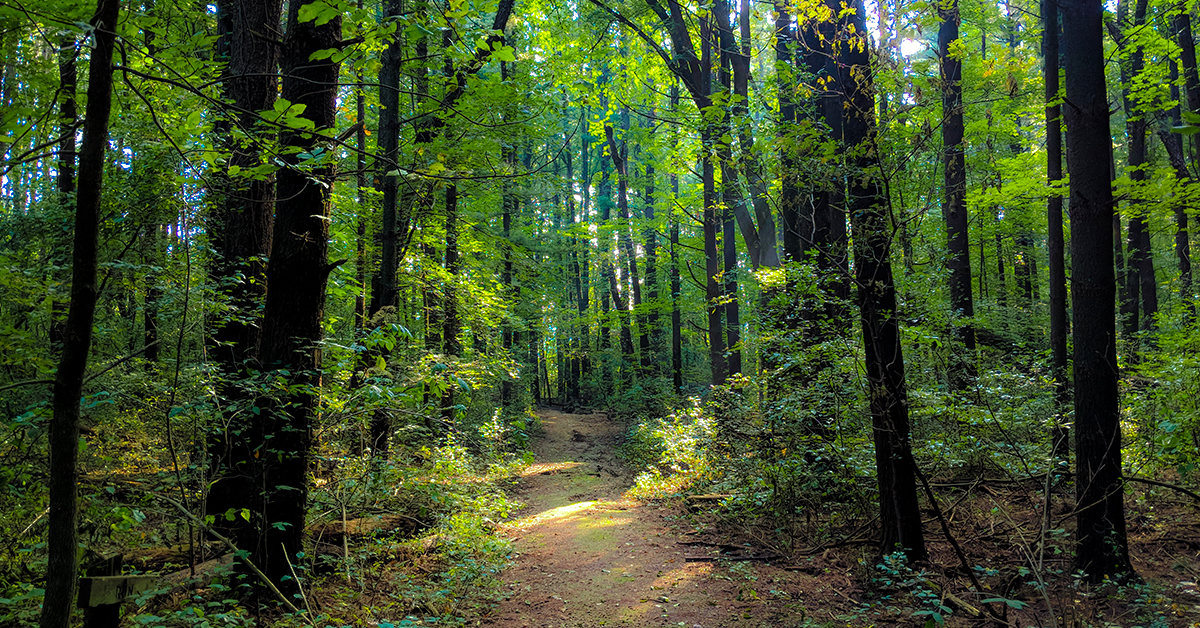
(479, 411, 828, 628)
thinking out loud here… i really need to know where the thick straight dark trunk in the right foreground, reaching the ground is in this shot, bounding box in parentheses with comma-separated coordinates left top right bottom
(1060, 0, 1133, 582)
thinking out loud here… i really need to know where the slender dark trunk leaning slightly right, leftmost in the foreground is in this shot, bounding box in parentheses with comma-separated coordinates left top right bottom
(40, 0, 120, 628)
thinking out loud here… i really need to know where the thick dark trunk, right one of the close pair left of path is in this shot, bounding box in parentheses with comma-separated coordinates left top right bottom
(254, 2, 342, 592)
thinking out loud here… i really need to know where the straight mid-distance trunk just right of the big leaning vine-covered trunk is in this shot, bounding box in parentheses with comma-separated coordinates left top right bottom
(937, 0, 976, 390)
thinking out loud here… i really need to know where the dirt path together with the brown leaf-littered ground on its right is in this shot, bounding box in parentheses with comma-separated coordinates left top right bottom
(467, 409, 1200, 628)
